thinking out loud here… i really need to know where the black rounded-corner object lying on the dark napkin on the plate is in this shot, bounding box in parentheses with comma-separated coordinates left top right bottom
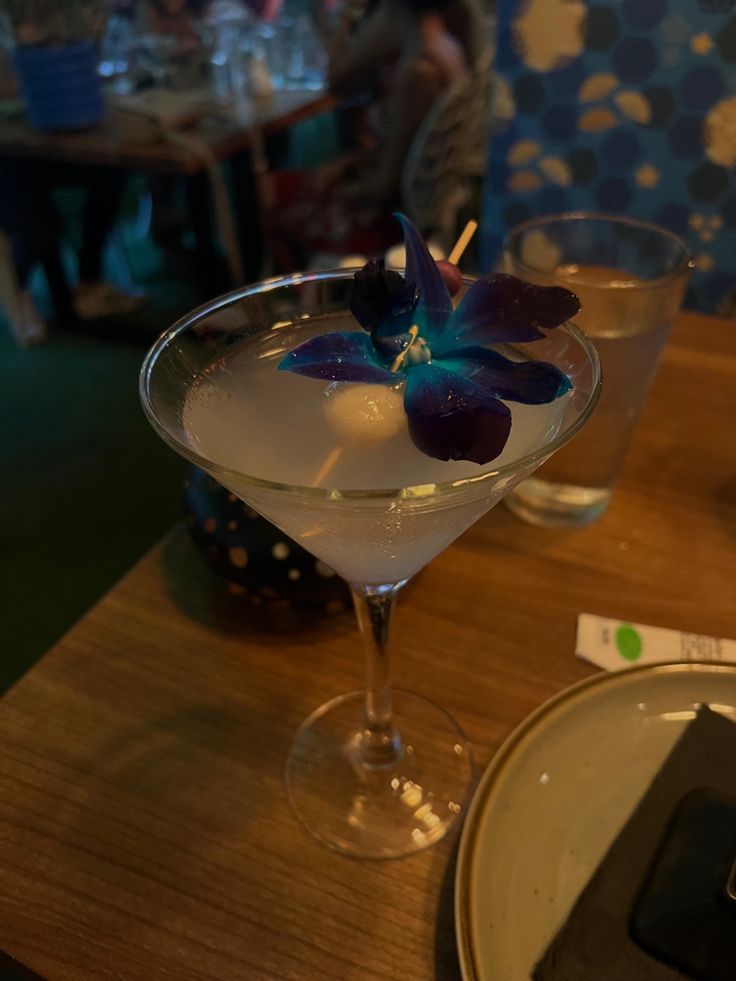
(630, 788, 736, 981)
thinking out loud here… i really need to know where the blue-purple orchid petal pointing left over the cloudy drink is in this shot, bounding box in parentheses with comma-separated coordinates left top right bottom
(279, 332, 396, 383)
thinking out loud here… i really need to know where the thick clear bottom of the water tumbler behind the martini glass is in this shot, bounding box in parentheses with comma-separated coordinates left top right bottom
(505, 477, 611, 528)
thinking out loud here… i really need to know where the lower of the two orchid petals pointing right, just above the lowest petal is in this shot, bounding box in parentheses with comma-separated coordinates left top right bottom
(434, 347, 572, 405)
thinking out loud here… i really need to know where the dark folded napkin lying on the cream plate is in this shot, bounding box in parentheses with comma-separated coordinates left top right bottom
(533, 706, 736, 981)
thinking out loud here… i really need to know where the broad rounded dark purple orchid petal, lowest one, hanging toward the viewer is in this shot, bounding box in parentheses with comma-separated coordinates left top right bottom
(404, 363, 511, 464)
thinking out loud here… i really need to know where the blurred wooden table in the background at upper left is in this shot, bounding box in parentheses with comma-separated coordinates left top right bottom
(0, 89, 336, 294)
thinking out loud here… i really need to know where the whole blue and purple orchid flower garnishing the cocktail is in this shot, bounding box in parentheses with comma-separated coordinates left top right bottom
(279, 215, 580, 464)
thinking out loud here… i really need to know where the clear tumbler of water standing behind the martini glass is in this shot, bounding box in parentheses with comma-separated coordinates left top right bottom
(502, 212, 692, 526)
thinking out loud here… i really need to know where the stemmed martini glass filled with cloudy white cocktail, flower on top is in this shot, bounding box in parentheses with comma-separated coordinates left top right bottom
(141, 270, 600, 858)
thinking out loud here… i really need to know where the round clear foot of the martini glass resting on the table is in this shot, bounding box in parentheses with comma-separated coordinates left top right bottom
(286, 691, 473, 858)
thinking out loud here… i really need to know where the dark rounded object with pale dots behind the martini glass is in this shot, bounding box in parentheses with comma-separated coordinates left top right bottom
(184, 467, 350, 613)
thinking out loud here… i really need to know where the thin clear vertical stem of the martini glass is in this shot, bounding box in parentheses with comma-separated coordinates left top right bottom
(351, 582, 404, 766)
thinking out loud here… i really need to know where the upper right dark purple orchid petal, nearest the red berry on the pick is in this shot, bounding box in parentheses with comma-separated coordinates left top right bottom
(436, 273, 580, 354)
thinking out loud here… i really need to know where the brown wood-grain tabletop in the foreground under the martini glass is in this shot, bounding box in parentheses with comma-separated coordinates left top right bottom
(0, 315, 736, 981)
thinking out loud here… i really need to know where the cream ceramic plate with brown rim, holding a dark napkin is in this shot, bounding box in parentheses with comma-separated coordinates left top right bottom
(455, 664, 736, 981)
